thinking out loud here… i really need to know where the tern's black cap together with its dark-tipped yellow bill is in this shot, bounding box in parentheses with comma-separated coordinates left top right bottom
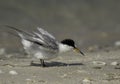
(61, 39, 84, 56)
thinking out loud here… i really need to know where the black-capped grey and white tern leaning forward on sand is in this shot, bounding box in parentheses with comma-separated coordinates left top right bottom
(5, 25, 84, 67)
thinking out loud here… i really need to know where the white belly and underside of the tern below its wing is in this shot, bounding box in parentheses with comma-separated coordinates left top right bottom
(22, 39, 58, 60)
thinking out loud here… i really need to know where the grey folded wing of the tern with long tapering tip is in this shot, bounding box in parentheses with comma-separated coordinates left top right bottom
(6, 25, 58, 51)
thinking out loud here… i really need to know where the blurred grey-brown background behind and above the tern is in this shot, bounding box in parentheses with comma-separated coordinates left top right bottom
(0, 0, 120, 51)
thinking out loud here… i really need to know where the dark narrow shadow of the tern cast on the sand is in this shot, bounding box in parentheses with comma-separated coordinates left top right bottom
(30, 61, 84, 67)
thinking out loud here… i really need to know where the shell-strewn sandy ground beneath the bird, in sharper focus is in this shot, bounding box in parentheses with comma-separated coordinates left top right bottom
(0, 50, 120, 84)
